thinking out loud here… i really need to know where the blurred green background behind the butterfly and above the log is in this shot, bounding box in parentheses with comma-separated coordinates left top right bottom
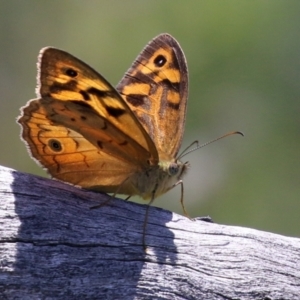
(0, 0, 300, 236)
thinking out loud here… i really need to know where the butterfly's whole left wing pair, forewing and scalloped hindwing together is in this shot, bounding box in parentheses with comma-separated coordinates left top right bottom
(18, 48, 158, 191)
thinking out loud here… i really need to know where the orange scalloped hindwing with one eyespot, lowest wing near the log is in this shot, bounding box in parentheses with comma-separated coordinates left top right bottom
(19, 99, 138, 194)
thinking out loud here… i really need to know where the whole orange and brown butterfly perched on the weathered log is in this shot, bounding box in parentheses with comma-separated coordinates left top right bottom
(17, 34, 241, 245)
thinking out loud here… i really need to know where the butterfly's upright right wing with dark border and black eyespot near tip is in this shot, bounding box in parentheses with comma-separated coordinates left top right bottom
(116, 34, 188, 159)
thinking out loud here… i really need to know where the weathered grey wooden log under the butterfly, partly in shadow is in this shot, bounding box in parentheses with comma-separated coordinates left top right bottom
(0, 164, 300, 300)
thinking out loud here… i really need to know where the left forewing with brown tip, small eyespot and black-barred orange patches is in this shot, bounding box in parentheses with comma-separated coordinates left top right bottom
(38, 48, 157, 161)
